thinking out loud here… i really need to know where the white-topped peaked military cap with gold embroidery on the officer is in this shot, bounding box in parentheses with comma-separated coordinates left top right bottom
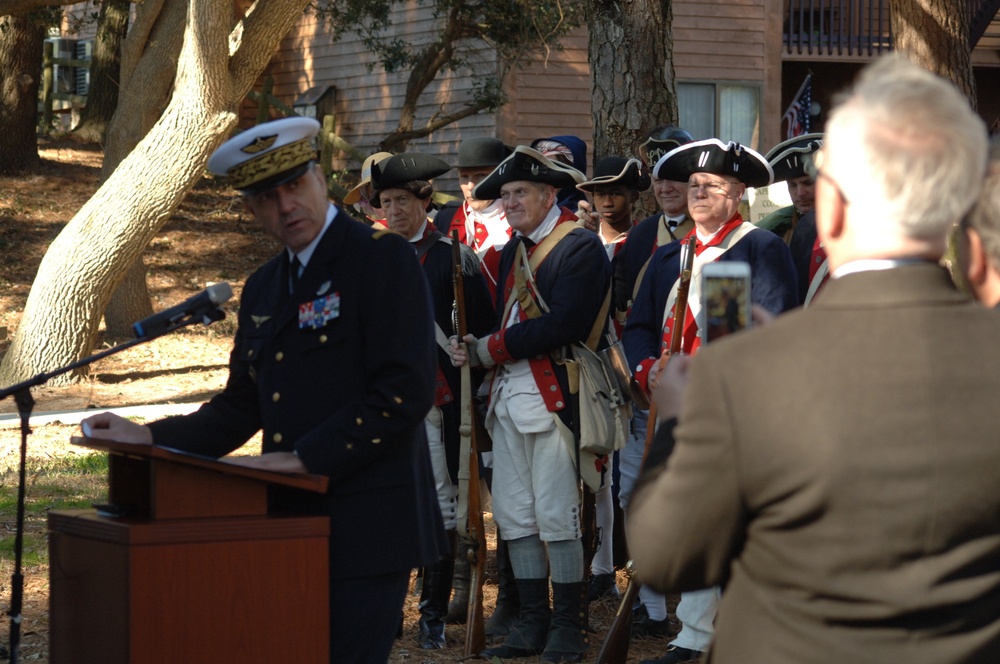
(208, 117, 320, 191)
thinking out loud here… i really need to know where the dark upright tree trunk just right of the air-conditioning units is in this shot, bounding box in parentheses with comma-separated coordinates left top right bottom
(73, 0, 130, 143)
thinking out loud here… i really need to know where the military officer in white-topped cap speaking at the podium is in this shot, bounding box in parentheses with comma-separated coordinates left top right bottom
(84, 118, 448, 663)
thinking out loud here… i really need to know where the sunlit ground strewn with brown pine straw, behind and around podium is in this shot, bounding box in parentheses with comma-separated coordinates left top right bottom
(0, 139, 680, 664)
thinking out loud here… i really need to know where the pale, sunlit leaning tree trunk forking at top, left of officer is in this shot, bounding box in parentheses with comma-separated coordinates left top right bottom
(0, 0, 307, 384)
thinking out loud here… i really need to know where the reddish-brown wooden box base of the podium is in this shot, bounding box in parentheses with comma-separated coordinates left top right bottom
(49, 510, 330, 664)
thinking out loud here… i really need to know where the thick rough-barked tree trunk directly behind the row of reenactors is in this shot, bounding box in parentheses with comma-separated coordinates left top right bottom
(587, 0, 677, 218)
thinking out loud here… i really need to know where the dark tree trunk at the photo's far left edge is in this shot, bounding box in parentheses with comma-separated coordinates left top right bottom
(0, 16, 45, 173)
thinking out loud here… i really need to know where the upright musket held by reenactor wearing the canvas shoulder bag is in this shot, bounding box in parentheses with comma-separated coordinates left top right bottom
(451, 231, 486, 657)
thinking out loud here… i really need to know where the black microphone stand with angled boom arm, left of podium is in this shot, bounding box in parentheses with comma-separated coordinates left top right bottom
(0, 307, 226, 664)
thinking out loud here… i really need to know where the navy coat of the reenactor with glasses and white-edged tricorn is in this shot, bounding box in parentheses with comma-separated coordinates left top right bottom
(622, 230, 798, 370)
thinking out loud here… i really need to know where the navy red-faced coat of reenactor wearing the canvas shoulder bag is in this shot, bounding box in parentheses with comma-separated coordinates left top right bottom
(489, 215, 611, 430)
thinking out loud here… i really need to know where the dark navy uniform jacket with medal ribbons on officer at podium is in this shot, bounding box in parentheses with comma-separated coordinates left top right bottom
(150, 211, 448, 580)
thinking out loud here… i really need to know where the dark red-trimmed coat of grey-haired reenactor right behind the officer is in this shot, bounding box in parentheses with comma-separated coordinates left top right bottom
(415, 230, 496, 482)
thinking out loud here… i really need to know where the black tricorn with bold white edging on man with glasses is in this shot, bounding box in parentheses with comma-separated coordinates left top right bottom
(653, 138, 774, 188)
